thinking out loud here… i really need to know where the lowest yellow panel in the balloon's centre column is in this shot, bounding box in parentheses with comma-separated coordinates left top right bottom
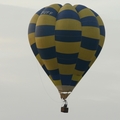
(58, 64, 75, 75)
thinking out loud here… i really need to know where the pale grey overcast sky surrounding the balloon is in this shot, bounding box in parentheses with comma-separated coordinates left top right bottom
(0, 0, 120, 120)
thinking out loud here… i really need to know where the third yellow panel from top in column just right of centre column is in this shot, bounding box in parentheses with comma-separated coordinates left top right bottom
(78, 47, 96, 61)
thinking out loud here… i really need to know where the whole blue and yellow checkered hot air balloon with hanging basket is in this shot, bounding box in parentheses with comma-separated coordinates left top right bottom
(28, 3, 105, 112)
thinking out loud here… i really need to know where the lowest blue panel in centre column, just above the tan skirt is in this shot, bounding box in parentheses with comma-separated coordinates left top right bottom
(60, 75, 72, 85)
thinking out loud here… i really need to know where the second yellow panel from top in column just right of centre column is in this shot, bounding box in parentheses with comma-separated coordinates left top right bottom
(82, 26, 100, 39)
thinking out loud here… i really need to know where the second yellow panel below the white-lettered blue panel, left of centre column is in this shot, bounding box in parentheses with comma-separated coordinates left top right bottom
(35, 35, 55, 48)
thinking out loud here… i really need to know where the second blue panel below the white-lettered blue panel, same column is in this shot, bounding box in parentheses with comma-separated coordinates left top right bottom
(38, 47, 56, 59)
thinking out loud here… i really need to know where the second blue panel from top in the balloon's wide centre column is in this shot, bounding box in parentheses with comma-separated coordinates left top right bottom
(55, 30, 81, 42)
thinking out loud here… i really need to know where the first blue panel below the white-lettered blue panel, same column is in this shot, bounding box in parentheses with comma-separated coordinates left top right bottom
(35, 25, 55, 37)
